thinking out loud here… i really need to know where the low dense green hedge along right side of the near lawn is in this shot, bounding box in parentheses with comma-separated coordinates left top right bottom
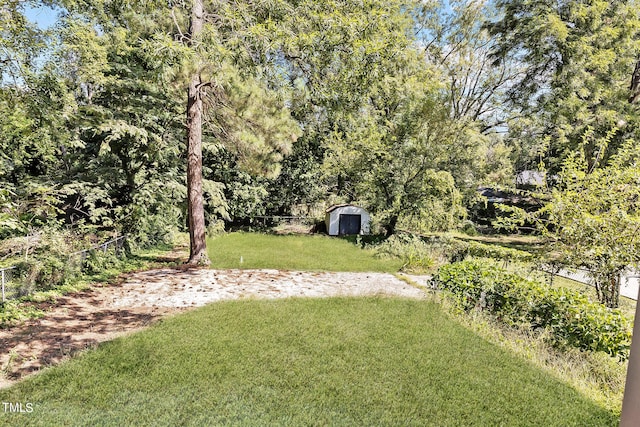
(432, 261, 631, 360)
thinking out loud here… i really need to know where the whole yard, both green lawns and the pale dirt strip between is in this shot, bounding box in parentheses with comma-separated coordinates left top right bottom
(0, 233, 618, 426)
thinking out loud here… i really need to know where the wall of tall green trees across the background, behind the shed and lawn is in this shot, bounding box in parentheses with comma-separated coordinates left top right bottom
(0, 0, 640, 306)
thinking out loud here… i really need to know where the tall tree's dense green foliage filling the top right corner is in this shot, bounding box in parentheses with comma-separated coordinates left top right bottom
(487, 0, 640, 173)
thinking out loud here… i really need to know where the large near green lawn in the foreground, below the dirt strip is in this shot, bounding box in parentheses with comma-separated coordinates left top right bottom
(0, 298, 618, 426)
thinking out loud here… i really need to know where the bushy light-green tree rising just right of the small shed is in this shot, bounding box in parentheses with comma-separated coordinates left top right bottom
(325, 63, 464, 235)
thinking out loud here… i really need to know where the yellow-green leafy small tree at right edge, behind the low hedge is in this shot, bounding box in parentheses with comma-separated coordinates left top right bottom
(499, 139, 640, 307)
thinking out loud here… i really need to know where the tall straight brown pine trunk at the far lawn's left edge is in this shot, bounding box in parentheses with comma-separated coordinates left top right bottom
(187, 0, 211, 265)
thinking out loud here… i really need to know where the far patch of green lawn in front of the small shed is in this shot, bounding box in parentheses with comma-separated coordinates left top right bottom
(207, 233, 402, 272)
